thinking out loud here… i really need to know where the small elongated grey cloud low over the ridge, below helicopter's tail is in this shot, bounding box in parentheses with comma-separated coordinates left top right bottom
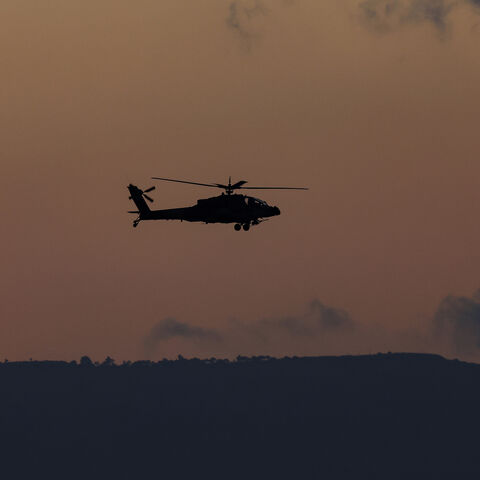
(144, 317, 222, 355)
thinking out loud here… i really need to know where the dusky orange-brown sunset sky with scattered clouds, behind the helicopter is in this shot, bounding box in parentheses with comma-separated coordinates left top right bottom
(0, 0, 480, 361)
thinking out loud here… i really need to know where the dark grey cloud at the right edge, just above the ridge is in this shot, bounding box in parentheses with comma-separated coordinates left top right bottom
(434, 290, 480, 355)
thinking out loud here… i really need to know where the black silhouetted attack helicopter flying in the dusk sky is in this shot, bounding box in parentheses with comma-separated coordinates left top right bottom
(127, 177, 308, 232)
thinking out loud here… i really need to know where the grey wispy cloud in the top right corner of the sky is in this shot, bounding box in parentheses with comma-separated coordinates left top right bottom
(358, 0, 480, 36)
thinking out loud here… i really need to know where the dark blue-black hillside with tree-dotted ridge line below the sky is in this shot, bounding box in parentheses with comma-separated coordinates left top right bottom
(0, 354, 480, 479)
